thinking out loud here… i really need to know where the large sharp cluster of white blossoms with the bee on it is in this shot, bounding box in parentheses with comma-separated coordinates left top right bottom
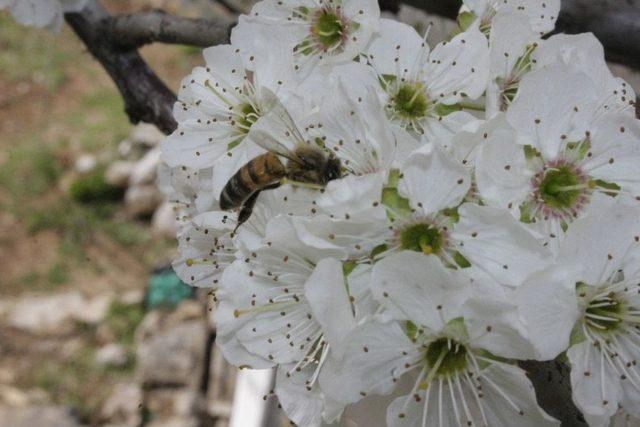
(162, 0, 640, 427)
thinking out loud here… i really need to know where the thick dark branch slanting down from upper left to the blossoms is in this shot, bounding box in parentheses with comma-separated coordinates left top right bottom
(65, 0, 177, 133)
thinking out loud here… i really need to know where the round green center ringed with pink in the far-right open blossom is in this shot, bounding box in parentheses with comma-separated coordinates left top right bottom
(539, 165, 588, 209)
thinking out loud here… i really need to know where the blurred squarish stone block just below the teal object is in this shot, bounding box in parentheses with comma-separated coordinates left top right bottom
(137, 320, 207, 387)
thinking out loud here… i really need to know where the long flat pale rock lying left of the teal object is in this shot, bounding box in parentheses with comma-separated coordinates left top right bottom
(9, 292, 112, 333)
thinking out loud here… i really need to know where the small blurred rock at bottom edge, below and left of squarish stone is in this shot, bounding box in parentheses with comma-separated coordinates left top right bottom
(100, 383, 142, 427)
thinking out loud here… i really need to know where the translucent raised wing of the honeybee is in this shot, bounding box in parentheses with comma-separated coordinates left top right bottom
(250, 88, 304, 165)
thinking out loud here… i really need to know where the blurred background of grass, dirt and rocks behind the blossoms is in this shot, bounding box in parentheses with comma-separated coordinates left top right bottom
(0, 0, 640, 427)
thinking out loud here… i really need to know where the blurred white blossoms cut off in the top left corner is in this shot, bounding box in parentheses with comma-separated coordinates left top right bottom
(0, 0, 87, 32)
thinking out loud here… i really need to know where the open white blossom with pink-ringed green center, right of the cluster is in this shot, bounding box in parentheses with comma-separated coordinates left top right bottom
(475, 65, 640, 248)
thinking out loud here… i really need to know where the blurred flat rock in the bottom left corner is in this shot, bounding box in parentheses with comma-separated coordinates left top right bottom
(0, 406, 81, 427)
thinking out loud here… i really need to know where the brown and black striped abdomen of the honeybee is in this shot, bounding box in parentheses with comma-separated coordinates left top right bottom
(220, 153, 285, 210)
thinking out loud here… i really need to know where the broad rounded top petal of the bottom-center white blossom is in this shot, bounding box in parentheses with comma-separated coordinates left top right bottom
(371, 251, 471, 330)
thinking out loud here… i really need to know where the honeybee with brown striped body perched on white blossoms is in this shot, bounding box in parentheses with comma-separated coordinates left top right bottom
(220, 96, 341, 227)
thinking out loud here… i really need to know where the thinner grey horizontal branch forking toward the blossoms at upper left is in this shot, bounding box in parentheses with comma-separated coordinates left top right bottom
(104, 10, 233, 47)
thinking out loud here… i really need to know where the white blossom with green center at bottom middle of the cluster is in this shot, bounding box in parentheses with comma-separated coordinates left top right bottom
(320, 252, 558, 426)
